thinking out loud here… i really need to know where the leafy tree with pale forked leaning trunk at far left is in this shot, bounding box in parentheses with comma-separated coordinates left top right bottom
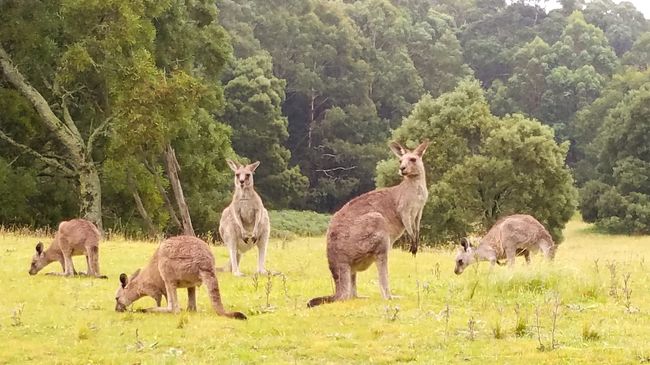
(0, 1, 172, 229)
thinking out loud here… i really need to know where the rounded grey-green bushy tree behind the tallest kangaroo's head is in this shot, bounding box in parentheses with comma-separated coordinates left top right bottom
(377, 81, 576, 243)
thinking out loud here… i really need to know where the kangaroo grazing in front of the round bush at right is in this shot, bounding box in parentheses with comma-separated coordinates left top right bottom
(454, 214, 555, 275)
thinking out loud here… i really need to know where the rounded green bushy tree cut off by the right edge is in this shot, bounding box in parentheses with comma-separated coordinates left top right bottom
(580, 82, 650, 234)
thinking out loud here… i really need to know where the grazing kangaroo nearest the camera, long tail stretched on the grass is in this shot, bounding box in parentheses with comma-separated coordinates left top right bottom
(115, 236, 246, 319)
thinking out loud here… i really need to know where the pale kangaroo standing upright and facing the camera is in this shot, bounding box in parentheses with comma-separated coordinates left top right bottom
(219, 160, 271, 276)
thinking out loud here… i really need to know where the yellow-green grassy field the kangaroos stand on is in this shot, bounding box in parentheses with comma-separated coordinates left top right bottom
(0, 221, 650, 364)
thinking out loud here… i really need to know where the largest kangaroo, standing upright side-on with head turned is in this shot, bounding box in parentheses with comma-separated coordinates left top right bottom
(307, 141, 429, 307)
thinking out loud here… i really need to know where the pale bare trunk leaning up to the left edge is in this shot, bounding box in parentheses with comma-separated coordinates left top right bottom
(0, 46, 103, 231)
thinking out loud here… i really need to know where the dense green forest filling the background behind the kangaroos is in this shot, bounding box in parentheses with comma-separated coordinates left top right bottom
(0, 0, 650, 242)
